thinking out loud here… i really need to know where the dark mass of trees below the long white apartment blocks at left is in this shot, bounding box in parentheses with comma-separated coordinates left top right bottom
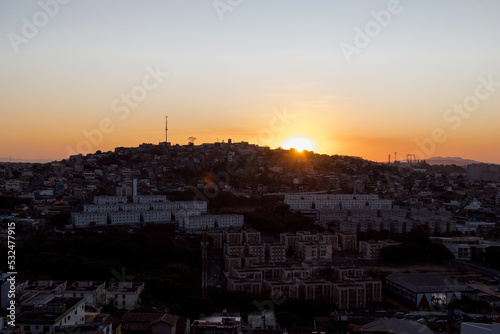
(6, 225, 201, 303)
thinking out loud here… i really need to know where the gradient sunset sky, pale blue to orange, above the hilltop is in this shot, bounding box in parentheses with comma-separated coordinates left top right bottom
(0, 0, 500, 163)
